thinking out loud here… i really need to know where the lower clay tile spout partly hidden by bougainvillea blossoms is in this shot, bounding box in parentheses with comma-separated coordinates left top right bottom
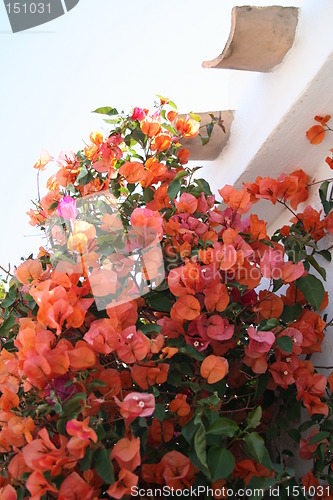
(179, 111, 234, 161)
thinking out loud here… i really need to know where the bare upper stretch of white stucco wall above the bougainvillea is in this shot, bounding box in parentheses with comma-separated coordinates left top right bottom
(205, 0, 333, 194)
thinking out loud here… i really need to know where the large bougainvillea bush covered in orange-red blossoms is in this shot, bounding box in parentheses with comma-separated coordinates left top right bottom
(0, 98, 333, 500)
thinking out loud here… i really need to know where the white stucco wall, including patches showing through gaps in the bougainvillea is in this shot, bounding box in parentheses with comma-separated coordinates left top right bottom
(198, 0, 333, 475)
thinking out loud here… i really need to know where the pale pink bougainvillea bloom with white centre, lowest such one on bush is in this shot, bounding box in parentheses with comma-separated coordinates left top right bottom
(114, 392, 155, 422)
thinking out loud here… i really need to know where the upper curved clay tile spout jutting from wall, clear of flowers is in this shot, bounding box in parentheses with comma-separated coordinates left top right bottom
(202, 6, 298, 72)
